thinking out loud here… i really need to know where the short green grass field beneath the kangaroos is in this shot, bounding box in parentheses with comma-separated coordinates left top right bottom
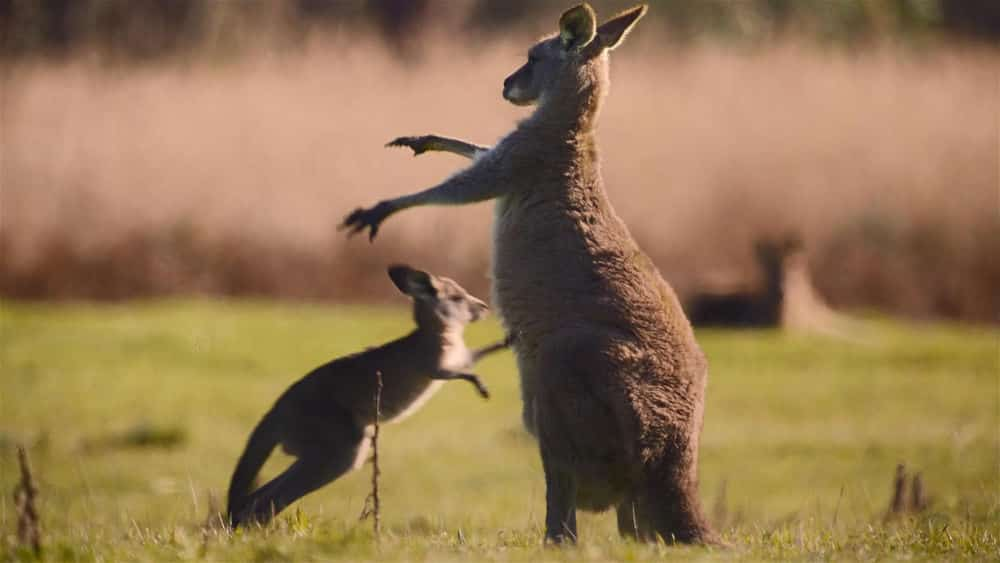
(0, 301, 1000, 561)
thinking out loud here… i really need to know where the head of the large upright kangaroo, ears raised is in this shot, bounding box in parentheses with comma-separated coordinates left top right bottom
(503, 3, 646, 109)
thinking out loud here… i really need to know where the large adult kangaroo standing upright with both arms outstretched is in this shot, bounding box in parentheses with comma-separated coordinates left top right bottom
(342, 4, 716, 543)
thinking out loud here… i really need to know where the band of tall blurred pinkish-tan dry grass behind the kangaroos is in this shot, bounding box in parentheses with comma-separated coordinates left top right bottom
(0, 35, 1000, 320)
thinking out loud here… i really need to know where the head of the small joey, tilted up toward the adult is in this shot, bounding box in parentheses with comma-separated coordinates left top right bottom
(389, 265, 489, 331)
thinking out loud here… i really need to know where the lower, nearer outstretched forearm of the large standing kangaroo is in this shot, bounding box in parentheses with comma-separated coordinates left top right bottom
(339, 148, 511, 240)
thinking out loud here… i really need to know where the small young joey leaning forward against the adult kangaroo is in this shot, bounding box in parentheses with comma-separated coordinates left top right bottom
(227, 266, 506, 526)
